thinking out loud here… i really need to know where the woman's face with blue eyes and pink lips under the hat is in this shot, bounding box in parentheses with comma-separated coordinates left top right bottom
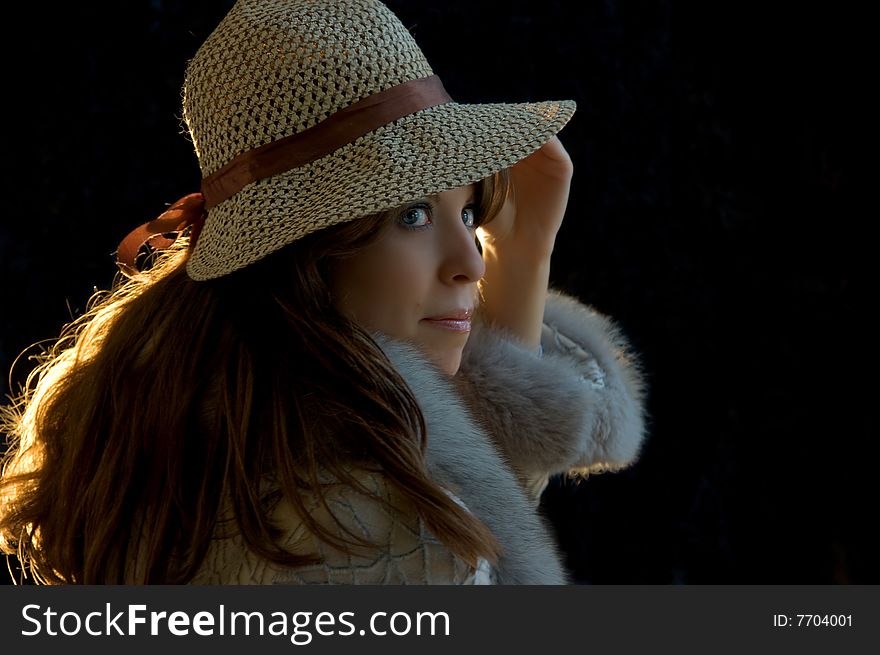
(332, 185, 485, 375)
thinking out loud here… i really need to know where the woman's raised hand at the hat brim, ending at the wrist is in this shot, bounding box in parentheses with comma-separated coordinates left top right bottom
(480, 136, 574, 261)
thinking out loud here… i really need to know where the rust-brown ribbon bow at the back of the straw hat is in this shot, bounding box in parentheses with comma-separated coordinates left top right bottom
(116, 193, 207, 277)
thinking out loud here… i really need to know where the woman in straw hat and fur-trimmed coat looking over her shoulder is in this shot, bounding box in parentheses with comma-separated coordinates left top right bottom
(0, 0, 643, 584)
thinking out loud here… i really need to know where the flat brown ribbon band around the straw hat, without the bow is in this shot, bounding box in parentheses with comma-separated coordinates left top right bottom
(202, 75, 452, 209)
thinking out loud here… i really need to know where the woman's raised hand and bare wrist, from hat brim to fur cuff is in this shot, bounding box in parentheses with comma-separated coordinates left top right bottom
(480, 137, 574, 350)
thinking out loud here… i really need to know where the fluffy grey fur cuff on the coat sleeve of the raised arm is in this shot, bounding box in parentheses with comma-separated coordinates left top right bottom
(457, 292, 644, 487)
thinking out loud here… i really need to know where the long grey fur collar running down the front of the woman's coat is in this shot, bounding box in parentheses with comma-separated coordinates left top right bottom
(376, 336, 566, 584)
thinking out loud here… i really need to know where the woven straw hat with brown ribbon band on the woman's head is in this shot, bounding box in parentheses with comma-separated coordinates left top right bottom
(183, 0, 575, 280)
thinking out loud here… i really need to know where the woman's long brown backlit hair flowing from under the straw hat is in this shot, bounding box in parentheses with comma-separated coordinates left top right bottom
(0, 174, 508, 584)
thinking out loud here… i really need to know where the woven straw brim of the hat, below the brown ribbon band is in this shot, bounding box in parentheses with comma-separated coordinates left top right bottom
(187, 100, 575, 280)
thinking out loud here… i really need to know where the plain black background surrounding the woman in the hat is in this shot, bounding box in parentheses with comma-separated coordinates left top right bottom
(0, 0, 880, 584)
